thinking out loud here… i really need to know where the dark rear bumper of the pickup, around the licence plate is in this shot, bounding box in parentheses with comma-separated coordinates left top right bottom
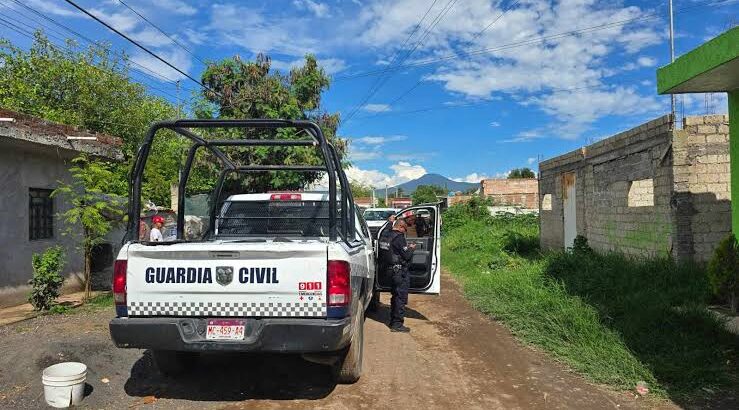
(110, 317, 351, 353)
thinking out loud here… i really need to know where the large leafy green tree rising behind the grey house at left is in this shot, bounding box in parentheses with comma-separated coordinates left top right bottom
(0, 32, 185, 203)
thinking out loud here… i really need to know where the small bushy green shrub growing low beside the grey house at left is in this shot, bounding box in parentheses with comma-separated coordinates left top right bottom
(28, 246, 65, 310)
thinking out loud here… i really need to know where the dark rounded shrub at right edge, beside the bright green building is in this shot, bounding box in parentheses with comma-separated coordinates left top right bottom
(706, 234, 739, 313)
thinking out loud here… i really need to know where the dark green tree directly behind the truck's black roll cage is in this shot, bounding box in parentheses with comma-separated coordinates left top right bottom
(195, 54, 347, 192)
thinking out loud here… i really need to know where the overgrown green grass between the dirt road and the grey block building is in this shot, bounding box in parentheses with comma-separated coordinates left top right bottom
(442, 205, 739, 400)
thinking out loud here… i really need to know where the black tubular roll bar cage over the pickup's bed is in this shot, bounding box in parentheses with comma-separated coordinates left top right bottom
(126, 119, 346, 242)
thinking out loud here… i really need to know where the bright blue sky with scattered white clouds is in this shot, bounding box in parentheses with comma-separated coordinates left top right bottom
(0, 0, 739, 188)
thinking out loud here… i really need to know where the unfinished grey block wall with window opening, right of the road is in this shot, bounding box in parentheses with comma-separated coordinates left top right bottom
(539, 116, 731, 261)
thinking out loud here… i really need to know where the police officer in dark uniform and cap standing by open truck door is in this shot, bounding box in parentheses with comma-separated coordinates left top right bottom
(379, 219, 416, 333)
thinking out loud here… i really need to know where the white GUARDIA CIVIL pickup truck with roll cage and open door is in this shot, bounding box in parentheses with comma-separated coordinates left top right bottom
(110, 120, 439, 383)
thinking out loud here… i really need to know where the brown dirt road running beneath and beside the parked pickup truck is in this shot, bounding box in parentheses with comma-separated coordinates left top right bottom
(0, 277, 654, 409)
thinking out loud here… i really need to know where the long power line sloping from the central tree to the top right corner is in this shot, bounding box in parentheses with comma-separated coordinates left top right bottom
(334, 0, 735, 81)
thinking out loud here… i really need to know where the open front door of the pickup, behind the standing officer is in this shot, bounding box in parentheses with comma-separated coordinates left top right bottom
(375, 204, 441, 295)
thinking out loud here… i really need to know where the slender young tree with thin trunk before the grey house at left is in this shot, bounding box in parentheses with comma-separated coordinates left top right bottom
(51, 155, 125, 300)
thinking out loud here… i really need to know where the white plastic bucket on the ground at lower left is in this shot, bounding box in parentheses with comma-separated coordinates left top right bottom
(41, 362, 87, 409)
